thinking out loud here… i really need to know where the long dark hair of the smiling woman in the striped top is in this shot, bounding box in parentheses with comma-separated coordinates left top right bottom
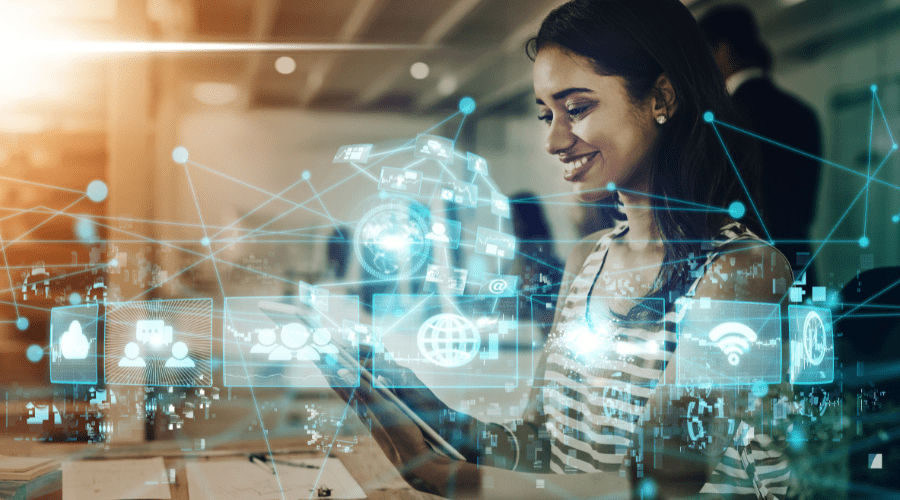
(526, 0, 758, 302)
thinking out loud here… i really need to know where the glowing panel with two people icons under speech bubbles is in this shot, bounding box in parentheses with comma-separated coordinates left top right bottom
(103, 299, 213, 387)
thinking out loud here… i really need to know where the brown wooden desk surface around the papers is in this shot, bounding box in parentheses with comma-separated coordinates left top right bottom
(0, 436, 437, 500)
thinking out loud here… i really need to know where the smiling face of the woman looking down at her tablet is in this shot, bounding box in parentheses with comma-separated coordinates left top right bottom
(534, 46, 660, 201)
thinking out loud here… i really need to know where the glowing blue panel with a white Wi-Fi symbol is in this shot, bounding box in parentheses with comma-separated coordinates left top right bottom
(675, 299, 782, 386)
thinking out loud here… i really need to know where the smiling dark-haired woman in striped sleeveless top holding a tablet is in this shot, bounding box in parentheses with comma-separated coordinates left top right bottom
(332, 0, 793, 499)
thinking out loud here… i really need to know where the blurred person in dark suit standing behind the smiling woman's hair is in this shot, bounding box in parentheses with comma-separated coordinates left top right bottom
(699, 5, 822, 285)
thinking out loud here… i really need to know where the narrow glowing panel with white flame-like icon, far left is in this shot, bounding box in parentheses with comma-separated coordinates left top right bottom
(50, 304, 100, 384)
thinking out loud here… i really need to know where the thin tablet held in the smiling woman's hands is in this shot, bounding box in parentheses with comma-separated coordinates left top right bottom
(253, 300, 466, 461)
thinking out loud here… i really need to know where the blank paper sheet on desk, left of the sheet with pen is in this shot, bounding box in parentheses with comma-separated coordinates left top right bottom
(62, 457, 172, 500)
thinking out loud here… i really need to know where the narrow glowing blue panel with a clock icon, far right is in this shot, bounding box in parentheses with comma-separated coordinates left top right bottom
(788, 305, 834, 385)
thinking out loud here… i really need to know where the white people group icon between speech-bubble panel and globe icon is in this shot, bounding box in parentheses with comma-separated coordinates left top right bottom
(250, 323, 338, 361)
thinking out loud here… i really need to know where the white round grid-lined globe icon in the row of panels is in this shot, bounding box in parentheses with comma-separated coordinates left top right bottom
(418, 313, 481, 368)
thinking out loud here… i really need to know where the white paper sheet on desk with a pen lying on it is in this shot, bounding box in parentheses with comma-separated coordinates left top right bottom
(185, 458, 366, 500)
